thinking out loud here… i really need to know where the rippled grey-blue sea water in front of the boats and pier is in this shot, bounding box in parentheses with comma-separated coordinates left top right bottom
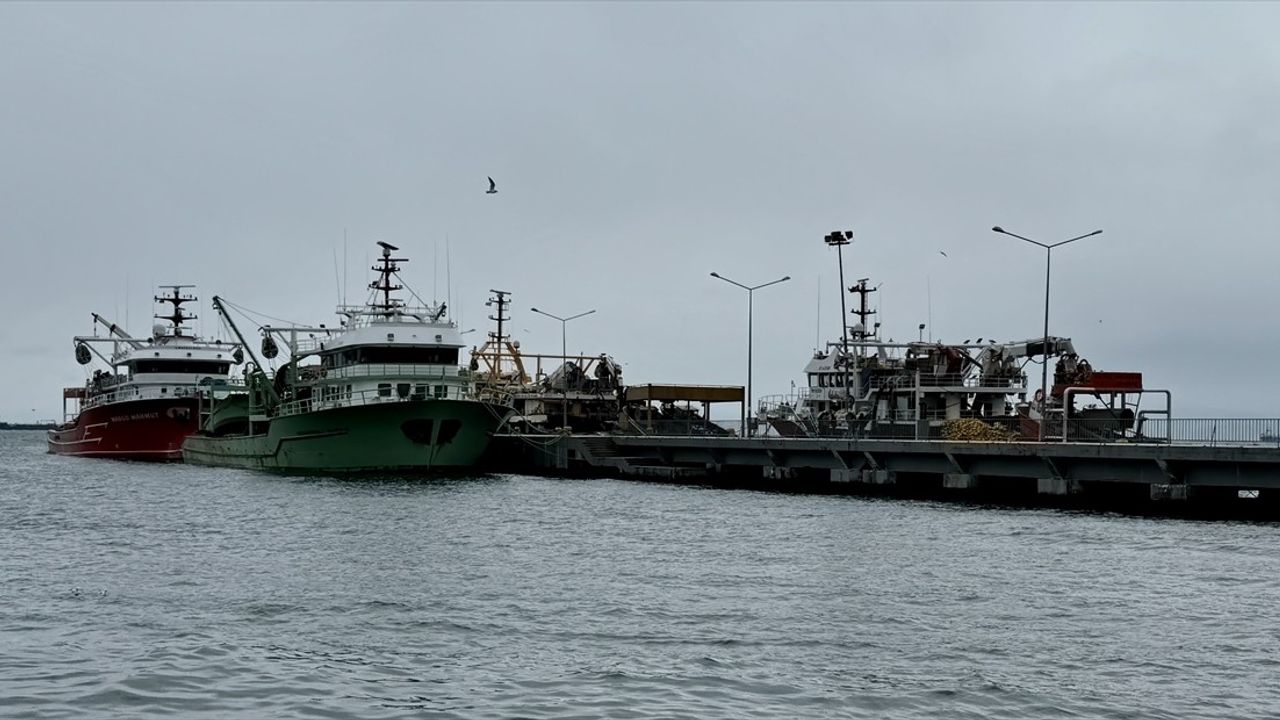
(0, 433, 1280, 720)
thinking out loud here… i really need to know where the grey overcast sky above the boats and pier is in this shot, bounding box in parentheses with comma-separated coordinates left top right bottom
(0, 3, 1280, 420)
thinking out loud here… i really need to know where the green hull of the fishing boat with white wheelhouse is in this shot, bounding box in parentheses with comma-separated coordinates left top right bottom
(182, 400, 511, 473)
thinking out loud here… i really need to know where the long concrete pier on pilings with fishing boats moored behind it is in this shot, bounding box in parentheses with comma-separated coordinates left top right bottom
(490, 436, 1280, 519)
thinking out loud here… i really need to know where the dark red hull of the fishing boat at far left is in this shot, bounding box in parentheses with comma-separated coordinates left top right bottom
(49, 397, 198, 461)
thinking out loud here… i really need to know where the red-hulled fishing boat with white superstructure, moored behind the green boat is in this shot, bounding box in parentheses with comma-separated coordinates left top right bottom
(49, 286, 243, 461)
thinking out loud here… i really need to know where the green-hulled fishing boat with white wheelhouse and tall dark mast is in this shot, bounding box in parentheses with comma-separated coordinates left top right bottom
(182, 242, 512, 473)
